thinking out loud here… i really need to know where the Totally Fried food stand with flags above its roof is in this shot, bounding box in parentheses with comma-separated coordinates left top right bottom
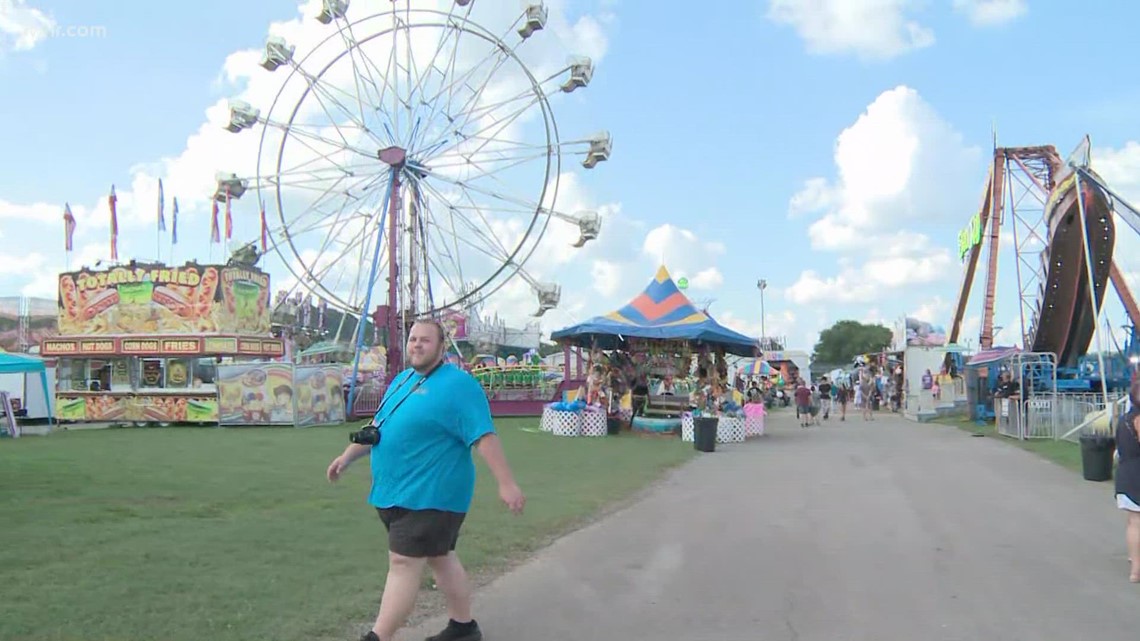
(41, 261, 285, 423)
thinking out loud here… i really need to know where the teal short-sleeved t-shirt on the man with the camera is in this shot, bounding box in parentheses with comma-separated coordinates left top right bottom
(368, 364, 495, 512)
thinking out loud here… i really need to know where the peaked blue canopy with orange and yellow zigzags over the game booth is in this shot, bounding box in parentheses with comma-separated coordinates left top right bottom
(551, 267, 759, 356)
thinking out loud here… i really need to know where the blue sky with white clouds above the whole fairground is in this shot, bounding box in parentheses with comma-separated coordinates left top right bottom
(0, 0, 1140, 350)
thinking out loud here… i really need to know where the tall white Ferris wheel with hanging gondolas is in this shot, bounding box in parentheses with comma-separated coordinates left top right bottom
(223, 0, 612, 364)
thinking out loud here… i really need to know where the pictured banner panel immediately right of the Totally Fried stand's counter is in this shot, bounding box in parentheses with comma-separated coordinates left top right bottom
(215, 363, 293, 425)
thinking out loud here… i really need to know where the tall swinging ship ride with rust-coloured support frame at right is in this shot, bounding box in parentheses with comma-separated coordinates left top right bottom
(946, 137, 1140, 387)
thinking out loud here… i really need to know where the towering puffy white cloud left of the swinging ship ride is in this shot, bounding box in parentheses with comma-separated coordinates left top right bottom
(789, 86, 982, 251)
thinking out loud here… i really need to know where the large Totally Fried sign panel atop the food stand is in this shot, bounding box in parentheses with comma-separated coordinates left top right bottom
(59, 263, 269, 335)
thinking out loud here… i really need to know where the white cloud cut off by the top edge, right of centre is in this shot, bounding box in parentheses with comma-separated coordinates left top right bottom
(768, 0, 935, 60)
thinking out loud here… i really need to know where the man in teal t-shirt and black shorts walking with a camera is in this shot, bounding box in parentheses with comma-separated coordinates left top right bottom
(326, 321, 526, 641)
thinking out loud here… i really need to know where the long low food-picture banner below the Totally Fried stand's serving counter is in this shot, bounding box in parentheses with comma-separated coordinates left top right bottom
(56, 393, 218, 423)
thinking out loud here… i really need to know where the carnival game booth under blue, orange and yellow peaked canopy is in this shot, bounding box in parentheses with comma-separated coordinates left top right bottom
(543, 267, 758, 436)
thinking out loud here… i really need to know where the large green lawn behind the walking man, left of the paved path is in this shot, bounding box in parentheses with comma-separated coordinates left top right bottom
(0, 419, 693, 641)
